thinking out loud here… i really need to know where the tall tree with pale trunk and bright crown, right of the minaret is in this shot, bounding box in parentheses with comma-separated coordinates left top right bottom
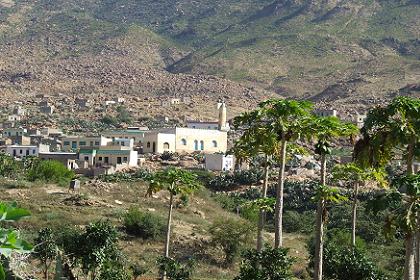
(259, 99, 312, 248)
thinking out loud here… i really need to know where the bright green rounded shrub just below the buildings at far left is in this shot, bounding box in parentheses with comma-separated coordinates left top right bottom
(27, 160, 74, 185)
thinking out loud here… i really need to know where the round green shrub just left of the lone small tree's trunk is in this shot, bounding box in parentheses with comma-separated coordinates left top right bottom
(124, 207, 166, 239)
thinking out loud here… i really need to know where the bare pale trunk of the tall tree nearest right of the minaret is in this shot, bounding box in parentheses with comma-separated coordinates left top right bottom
(274, 140, 287, 249)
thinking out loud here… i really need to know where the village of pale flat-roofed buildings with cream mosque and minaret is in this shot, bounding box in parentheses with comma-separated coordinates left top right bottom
(0, 95, 374, 176)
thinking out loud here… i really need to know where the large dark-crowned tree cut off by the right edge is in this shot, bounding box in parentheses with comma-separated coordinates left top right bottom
(355, 97, 420, 280)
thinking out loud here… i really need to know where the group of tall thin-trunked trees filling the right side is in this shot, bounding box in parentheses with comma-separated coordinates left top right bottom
(233, 97, 420, 280)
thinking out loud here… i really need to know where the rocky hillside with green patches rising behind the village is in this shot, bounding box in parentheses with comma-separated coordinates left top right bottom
(0, 0, 420, 106)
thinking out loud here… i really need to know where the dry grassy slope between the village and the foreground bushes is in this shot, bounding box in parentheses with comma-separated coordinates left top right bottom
(0, 180, 307, 279)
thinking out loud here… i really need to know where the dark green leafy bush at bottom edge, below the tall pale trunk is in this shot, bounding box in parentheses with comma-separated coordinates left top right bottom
(235, 247, 295, 280)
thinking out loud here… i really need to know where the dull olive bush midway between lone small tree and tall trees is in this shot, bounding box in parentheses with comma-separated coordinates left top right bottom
(209, 218, 254, 266)
